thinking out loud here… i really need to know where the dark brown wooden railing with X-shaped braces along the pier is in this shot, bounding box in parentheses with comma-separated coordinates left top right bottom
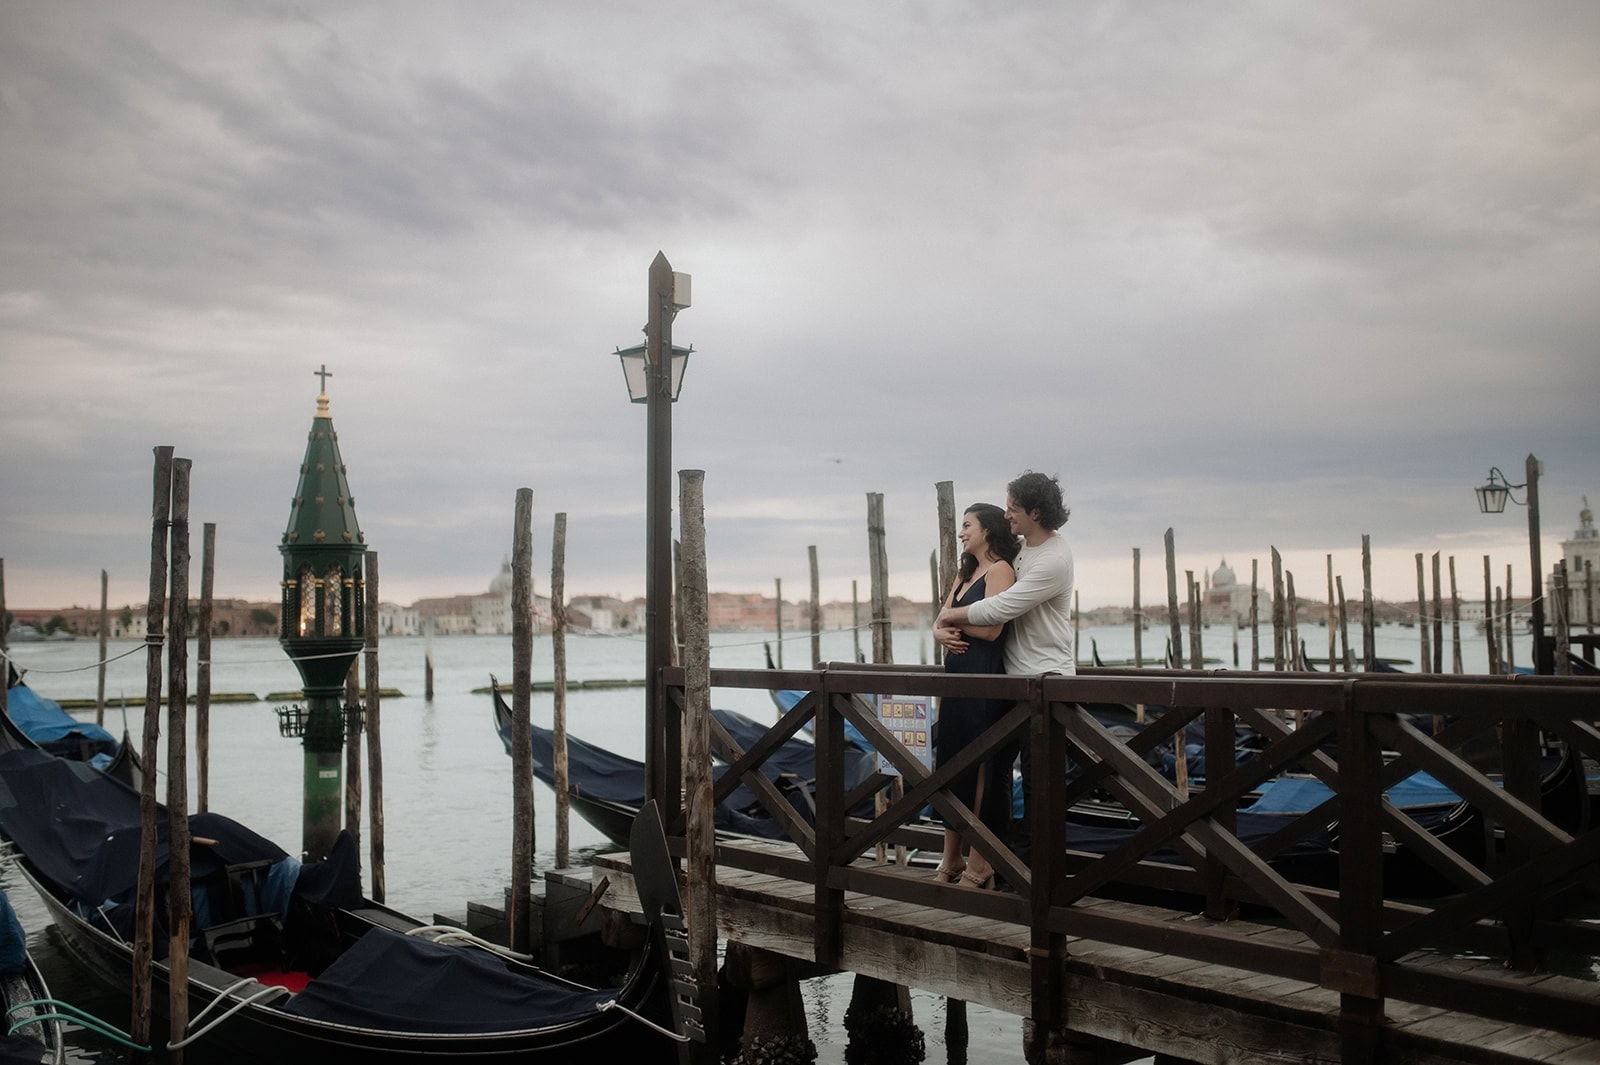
(669, 665, 1600, 1049)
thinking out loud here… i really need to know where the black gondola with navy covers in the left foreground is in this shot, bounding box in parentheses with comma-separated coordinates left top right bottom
(0, 703, 670, 1065)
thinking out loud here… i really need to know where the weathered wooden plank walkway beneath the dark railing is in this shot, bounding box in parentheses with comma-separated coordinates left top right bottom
(594, 841, 1600, 1065)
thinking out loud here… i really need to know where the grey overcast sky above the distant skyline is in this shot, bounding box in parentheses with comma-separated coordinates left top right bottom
(0, 0, 1600, 608)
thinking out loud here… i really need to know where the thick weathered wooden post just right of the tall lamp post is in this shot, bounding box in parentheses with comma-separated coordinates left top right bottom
(678, 470, 720, 1062)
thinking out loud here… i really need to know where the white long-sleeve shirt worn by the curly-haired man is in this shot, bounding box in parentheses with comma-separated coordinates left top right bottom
(966, 533, 1078, 676)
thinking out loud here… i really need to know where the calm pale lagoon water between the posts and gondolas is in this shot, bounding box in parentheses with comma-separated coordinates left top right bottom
(0, 625, 1530, 1065)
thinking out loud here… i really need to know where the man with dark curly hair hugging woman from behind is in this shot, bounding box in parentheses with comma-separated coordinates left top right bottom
(933, 470, 1077, 862)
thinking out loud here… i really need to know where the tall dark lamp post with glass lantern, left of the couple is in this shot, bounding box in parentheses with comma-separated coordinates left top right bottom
(616, 251, 694, 815)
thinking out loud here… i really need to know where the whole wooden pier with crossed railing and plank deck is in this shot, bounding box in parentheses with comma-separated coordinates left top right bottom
(624, 665, 1600, 1065)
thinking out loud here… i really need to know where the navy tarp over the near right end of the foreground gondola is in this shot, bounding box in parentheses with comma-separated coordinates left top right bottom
(282, 927, 616, 1033)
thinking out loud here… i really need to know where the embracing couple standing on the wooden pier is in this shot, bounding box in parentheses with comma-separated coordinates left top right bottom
(933, 470, 1077, 888)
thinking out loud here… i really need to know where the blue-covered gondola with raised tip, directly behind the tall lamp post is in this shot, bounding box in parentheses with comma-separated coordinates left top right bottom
(490, 676, 875, 846)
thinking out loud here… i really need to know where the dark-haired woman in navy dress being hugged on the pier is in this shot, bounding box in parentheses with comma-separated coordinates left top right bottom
(933, 504, 1019, 888)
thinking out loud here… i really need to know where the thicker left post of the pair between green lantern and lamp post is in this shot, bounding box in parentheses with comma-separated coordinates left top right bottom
(506, 488, 534, 953)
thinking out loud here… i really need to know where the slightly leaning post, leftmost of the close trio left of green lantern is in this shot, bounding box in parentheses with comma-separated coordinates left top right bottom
(130, 445, 173, 1046)
